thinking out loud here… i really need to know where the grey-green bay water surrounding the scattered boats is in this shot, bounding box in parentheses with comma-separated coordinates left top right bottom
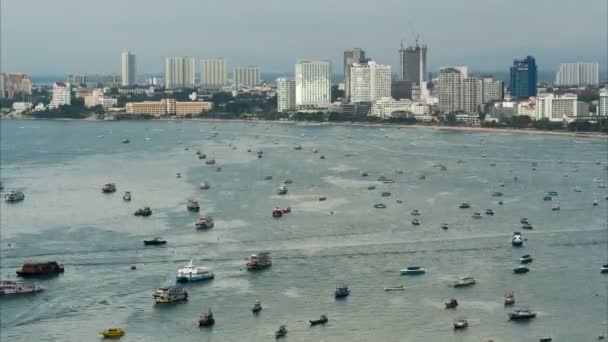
(0, 121, 608, 342)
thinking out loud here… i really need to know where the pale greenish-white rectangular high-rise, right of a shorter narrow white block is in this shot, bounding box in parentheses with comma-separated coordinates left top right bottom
(295, 59, 331, 108)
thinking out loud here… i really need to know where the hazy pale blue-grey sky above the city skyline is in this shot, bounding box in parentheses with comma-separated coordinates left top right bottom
(0, 0, 607, 75)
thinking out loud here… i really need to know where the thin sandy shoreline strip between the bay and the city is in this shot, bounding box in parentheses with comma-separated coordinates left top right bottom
(0, 117, 608, 140)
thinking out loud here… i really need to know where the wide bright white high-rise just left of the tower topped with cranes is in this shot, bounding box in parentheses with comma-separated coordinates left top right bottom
(350, 61, 391, 102)
